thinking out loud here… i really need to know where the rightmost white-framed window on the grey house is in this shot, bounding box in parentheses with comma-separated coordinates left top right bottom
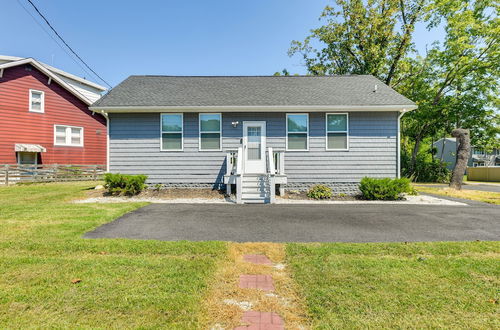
(326, 113, 349, 150)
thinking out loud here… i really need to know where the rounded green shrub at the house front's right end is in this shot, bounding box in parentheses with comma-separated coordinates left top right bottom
(359, 177, 415, 200)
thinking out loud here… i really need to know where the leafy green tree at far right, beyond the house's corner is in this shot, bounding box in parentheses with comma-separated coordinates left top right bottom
(397, 0, 500, 165)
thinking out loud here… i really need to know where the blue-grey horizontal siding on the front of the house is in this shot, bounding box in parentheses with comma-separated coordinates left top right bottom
(110, 112, 397, 185)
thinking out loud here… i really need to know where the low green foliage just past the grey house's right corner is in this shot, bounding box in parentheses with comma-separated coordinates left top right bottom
(401, 153, 451, 183)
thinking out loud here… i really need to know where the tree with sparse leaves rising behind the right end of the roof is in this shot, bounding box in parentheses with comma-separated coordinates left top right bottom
(289, 0, 427, 85)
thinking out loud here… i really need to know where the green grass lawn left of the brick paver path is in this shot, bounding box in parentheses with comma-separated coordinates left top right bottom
(0, 183, 226, 329)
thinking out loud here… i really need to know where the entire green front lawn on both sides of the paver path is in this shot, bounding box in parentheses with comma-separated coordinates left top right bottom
(0, 183, 500, 329)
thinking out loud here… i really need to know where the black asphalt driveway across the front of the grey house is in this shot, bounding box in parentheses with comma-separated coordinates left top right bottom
(84, 203, 500, 242)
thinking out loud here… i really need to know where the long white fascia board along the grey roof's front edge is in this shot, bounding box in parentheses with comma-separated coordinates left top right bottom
(90, 105, 417, 113)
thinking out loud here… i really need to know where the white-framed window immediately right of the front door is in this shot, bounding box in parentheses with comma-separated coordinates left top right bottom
(286, 113, 309, 151)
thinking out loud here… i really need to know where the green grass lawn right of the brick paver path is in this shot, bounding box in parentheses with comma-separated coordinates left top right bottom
(287, 242, 500, 329)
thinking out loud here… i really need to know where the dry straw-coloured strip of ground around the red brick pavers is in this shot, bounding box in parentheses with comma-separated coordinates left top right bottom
(202, 243, 309, 329)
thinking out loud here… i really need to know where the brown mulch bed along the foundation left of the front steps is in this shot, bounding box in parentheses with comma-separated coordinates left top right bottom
(86, 188, 224, 199)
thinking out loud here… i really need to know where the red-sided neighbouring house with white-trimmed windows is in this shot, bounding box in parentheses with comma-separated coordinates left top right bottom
(0, 56, 107, 165)
